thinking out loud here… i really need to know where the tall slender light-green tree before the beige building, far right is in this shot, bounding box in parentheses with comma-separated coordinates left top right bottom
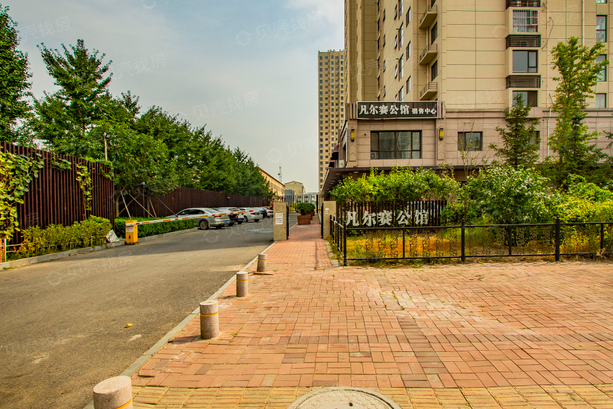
(549, 37, 609, 184)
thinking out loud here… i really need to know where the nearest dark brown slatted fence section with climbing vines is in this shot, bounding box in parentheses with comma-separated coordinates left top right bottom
(0, 143, 115, 244)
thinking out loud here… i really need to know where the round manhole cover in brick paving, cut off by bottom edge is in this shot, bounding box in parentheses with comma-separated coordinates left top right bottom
(289, 388, 400, 409)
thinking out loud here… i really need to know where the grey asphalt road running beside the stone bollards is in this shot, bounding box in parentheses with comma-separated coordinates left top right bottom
(0, 218, 290, 409)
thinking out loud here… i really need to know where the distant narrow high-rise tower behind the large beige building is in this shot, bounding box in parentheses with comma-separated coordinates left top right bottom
(318, 50, 345, 189)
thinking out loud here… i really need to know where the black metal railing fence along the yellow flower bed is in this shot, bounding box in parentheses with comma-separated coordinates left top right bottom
(331, 216, 613, 265)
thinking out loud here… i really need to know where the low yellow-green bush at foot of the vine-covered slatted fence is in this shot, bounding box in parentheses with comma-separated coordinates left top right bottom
(17, 216, 111, 258)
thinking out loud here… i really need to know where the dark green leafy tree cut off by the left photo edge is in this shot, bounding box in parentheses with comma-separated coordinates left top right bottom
(0, 4, 32, 142)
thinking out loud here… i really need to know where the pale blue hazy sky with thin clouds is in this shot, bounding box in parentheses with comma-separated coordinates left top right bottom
(0, 0, 343, 191)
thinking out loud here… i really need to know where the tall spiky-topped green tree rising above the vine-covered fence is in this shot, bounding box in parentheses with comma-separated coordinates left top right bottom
(32, 40, 112, 157)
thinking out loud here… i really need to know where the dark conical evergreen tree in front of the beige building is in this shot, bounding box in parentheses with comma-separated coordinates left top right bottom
(490, 94, 541, 169)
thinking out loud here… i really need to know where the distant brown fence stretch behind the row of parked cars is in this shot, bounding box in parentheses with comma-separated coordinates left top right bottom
(119, 187, 270, 217)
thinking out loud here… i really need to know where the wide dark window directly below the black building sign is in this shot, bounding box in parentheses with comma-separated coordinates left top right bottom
(370, 131, 421, 159)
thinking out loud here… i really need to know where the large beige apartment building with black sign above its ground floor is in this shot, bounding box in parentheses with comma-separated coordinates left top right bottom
(322, 0, 613, 195)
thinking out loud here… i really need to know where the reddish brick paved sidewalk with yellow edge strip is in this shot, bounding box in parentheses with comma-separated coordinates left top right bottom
(133, 224, 613, 408)
